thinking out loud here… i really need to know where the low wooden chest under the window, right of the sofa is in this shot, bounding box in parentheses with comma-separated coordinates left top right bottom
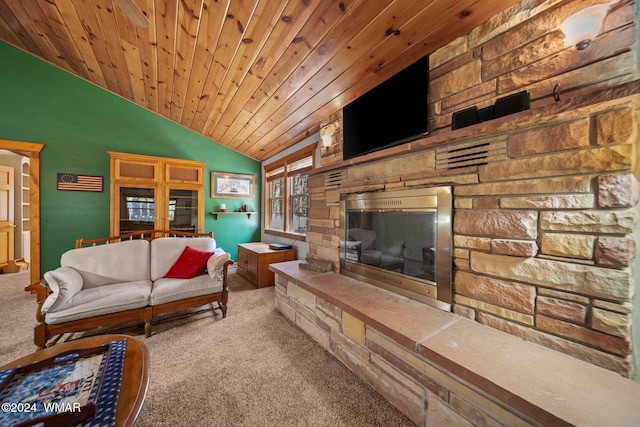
(238, 243, 296, 288)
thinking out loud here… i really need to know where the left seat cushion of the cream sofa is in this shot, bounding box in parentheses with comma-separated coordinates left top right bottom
(45, 280, 151, 325)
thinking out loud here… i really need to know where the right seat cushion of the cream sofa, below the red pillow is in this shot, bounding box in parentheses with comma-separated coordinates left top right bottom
(150, 274, 223, 306)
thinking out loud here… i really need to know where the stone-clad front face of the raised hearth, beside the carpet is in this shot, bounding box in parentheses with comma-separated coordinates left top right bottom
(275, 274, 536, 427)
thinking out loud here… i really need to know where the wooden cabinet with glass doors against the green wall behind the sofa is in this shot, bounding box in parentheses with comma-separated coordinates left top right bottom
(109, 152, 204, 236)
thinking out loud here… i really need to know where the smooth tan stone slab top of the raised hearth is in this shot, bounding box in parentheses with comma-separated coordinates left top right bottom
(269, 260, 640, 426)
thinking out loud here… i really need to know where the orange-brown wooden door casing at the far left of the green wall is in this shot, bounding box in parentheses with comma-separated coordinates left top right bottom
(0, 139, 44, 283)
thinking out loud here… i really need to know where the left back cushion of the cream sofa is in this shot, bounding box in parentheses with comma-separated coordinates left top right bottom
(60, 240, 150, 289)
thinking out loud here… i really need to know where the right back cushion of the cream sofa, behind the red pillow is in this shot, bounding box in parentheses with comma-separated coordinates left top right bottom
(151, 237, 216, 280)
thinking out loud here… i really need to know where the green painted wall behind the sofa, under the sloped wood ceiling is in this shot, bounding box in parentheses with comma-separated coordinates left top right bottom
(0, 42, 262, 273)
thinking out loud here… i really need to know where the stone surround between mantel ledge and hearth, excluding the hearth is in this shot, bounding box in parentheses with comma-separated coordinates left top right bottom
(307, 81, 640, 377)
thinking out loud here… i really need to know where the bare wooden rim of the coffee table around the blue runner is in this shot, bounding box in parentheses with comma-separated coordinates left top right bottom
(0, 335, 149, 426)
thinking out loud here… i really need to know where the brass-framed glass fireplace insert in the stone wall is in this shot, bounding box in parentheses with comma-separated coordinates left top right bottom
(340, 187, 452, 311)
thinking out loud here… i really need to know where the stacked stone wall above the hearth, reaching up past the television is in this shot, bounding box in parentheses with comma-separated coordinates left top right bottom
(307, 1, 640, 376)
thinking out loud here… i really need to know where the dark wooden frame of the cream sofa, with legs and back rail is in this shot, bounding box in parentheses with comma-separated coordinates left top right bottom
(25, 230, 233, 349)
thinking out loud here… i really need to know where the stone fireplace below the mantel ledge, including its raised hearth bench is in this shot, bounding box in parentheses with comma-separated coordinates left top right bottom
(274, 82, 640, 425)
